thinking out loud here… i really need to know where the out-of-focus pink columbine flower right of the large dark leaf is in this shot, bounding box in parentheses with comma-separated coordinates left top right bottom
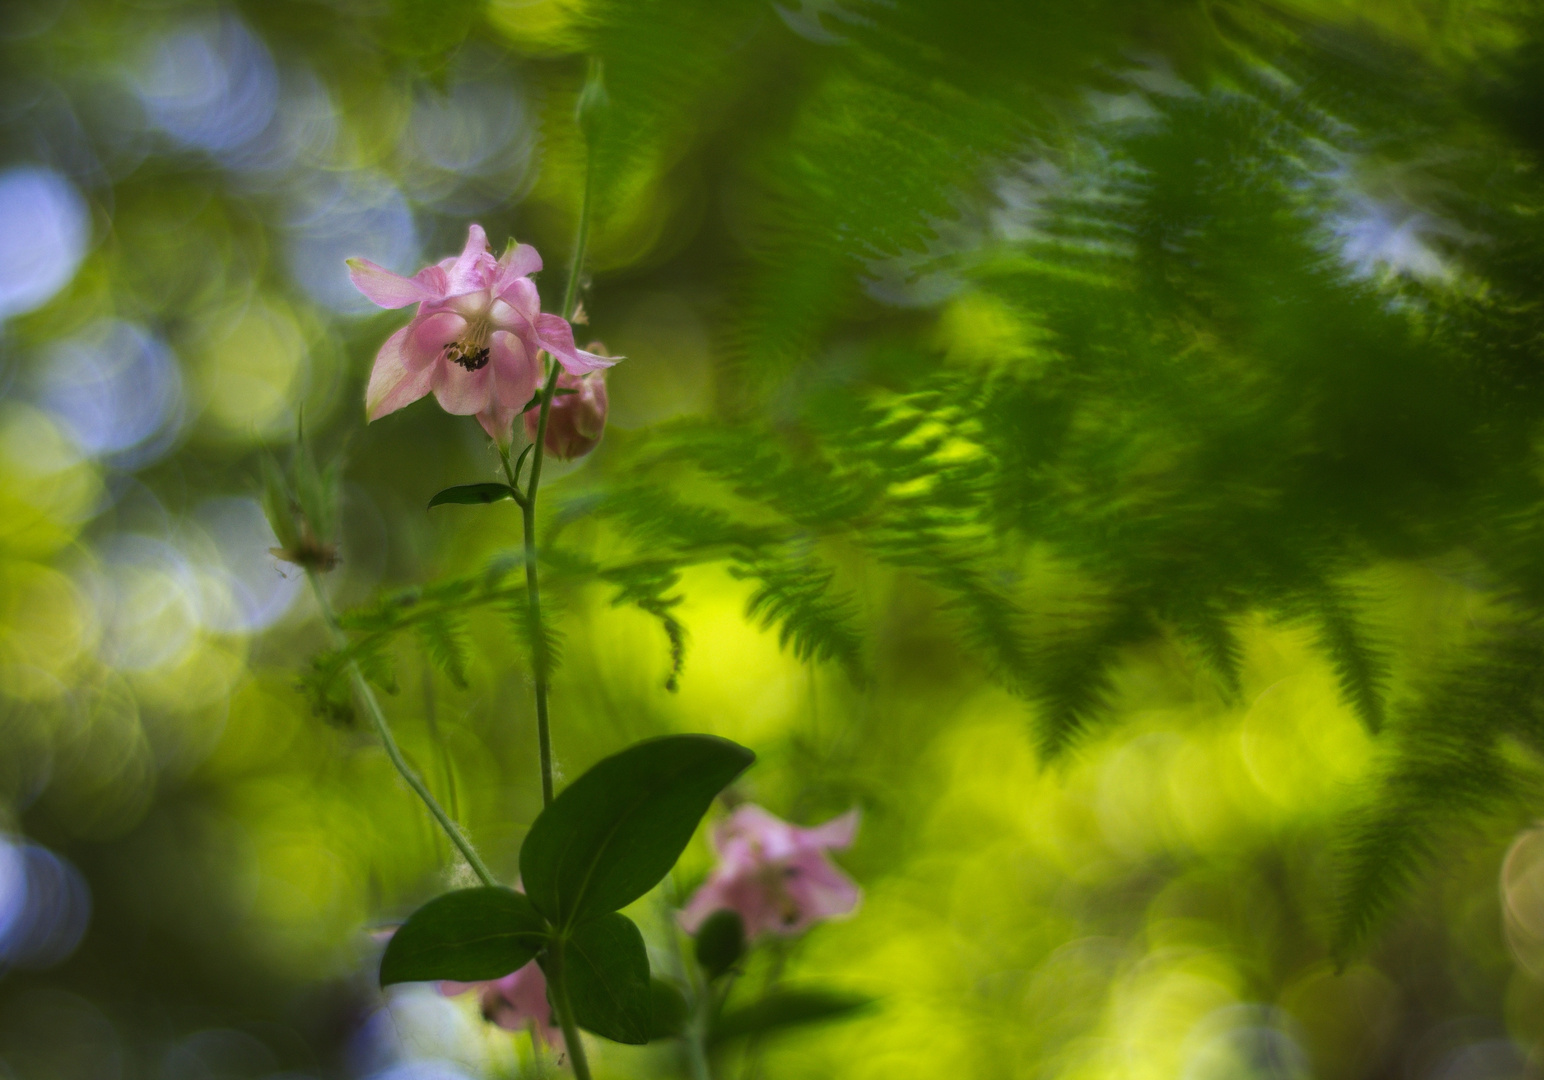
(681, 803, 862, 938)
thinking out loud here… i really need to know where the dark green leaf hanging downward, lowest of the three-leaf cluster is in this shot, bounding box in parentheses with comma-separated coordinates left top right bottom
(542, 912, 655, 1044)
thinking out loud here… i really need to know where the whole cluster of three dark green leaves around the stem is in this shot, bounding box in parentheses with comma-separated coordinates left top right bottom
(381, 735, 755, 1043)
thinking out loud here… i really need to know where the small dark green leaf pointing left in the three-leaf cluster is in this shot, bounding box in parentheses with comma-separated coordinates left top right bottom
(381, 885, 548, 986)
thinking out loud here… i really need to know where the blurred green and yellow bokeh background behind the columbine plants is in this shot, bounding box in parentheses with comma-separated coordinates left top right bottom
(9, 0, 1544, 1080)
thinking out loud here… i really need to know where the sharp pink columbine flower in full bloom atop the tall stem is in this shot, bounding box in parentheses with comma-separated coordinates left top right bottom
(349, 226, 616, 443)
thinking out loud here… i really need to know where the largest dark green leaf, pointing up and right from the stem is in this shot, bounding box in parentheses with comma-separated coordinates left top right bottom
(520, 735, 755, 929)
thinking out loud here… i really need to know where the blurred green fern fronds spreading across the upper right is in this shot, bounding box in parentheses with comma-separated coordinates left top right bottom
(301, 0, 1544, 964)
